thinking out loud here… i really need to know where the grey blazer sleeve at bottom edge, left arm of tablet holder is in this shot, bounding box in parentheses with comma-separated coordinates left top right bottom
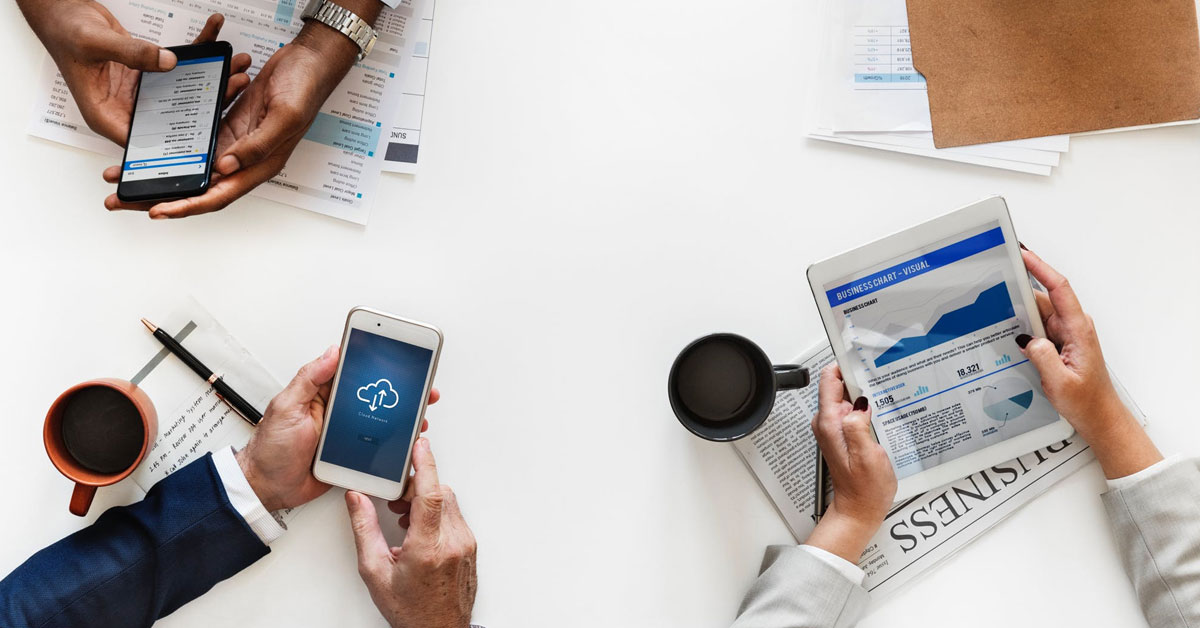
(733, 545, 868, 628)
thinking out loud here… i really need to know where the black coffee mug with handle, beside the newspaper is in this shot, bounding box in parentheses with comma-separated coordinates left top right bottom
(667, 334, 809, 442)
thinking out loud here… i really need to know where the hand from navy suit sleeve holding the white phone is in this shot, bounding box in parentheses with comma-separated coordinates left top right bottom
(236, 345, 440, 512)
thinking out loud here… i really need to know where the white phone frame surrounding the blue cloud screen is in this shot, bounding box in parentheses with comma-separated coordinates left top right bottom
(312, 306, 443, 501)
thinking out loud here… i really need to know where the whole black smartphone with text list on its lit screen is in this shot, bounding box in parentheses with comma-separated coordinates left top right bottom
(116, 42, 233, 202)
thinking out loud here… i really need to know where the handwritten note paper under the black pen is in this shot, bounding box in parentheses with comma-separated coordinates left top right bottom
(130, 299, 300, 516)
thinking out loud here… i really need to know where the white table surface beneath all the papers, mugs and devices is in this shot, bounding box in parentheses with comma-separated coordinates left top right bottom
(0, 0, 1200, 628)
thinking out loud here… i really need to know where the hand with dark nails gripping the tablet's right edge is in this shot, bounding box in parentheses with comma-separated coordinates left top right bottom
(1016, 250, 1163, 478)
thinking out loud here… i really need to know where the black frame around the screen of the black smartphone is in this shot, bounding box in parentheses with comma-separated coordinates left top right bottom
(116, 42, 233, 203)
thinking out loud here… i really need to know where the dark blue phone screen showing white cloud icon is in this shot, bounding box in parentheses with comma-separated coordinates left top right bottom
(320, 328, 433, 482)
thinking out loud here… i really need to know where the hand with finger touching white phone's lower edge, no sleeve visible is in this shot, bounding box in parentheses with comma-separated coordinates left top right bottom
(346, 438, 476, 628)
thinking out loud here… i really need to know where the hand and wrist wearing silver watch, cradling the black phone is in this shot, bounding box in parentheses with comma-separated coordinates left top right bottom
(104, 19, 364, 220)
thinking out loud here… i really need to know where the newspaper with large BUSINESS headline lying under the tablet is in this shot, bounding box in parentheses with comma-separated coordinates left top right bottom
(733, 343, 1146, 597)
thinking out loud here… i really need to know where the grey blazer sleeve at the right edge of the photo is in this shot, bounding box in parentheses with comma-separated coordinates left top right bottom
(1103, 460, 1200, 628)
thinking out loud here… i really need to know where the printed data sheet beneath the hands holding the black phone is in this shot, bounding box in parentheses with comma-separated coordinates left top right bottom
(29, 0, 426, 225)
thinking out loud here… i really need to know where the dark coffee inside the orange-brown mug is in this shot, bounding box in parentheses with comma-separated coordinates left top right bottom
(62, 385, 145, 474)
